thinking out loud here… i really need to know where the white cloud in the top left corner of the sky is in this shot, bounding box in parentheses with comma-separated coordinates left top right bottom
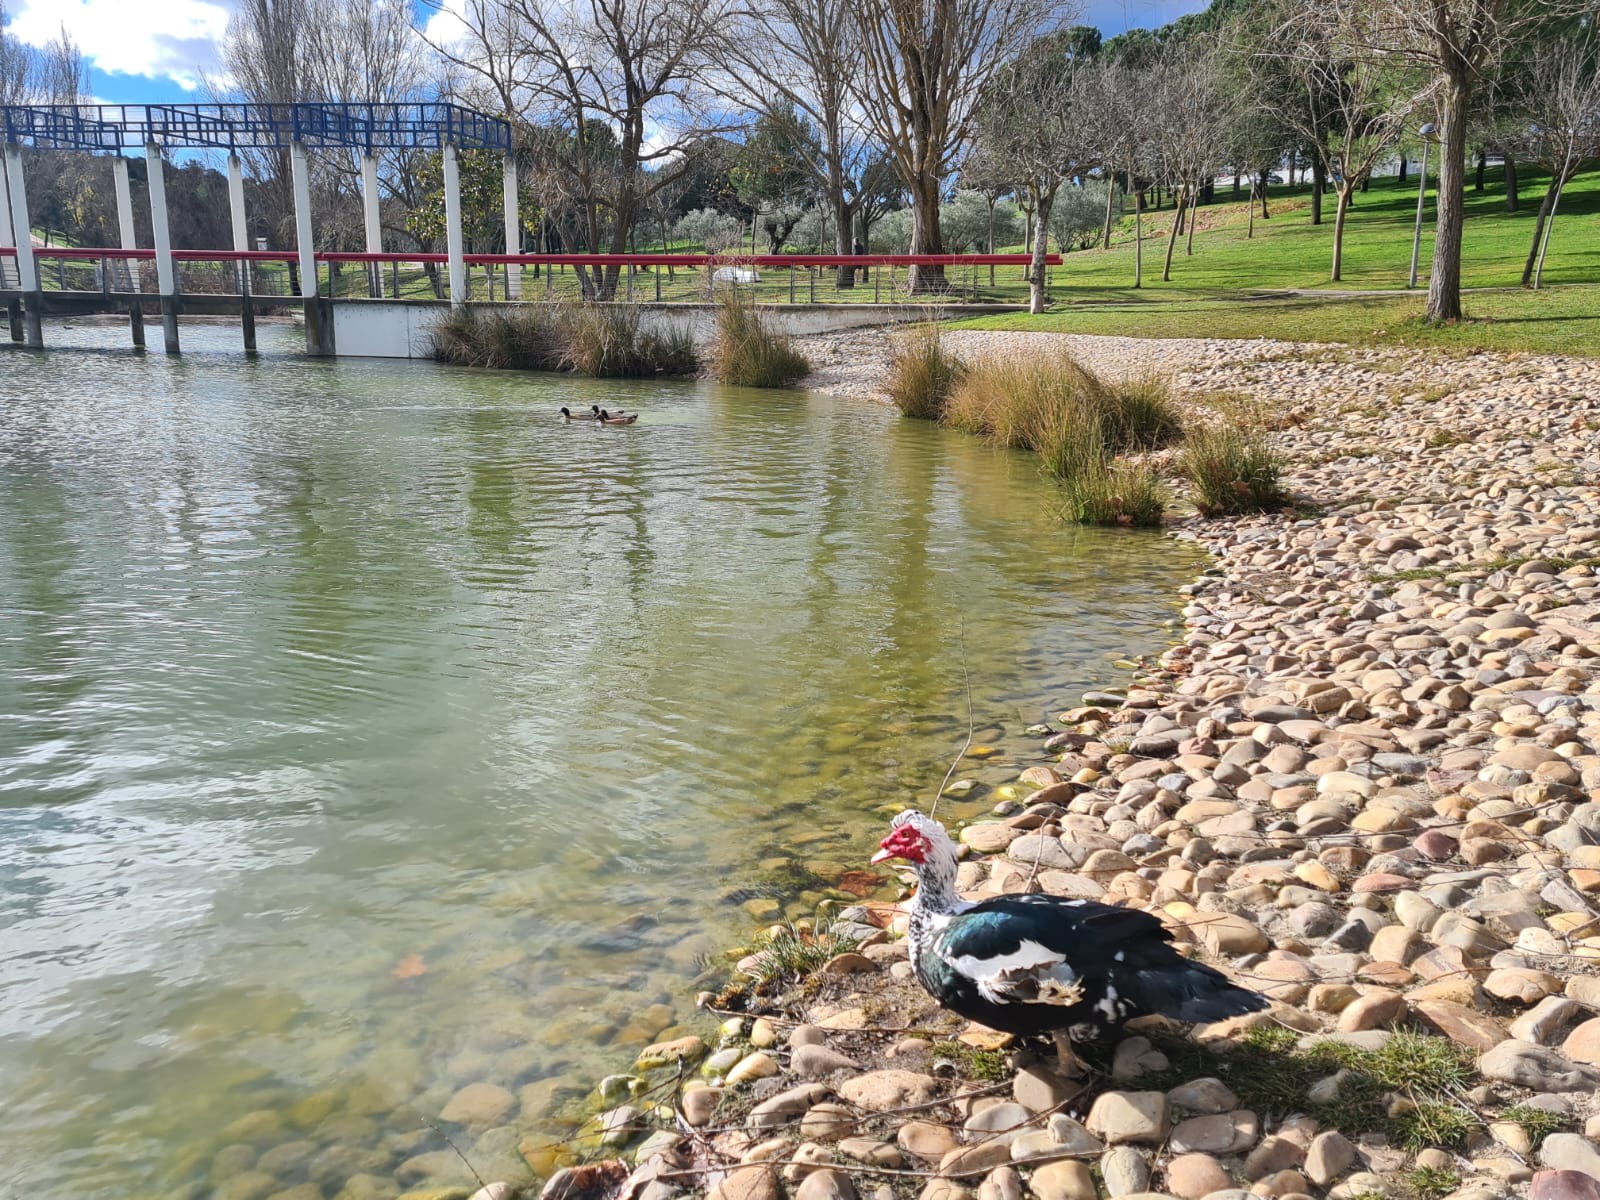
(10, 0, 229, 88)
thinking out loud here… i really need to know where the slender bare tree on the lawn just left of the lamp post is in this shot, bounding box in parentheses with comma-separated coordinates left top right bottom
(1256, 0, 1418, 278)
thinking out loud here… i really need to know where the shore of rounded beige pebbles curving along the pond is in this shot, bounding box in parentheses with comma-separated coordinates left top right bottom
(528, 333, 1600, 1200)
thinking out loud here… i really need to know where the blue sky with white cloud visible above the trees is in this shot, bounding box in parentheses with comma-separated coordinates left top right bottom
(8, 0, 1206, 104)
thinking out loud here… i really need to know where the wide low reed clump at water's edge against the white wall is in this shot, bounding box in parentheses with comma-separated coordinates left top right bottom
(430, 301, 699, 378)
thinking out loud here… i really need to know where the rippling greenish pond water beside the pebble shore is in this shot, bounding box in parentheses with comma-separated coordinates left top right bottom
(0, 323, 1195, 1200)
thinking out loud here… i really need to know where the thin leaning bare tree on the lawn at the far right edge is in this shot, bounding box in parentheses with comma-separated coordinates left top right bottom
(1520, 38, 1600, 288)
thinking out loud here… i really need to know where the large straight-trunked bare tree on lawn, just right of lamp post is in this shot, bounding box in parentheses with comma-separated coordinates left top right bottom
(1357, 0, 1592, 322)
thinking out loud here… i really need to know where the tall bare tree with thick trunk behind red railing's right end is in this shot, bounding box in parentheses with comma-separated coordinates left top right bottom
(851, 0, 1075, 291)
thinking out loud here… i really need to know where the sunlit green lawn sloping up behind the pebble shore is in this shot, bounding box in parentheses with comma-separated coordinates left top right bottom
(963, 168, 1600, 355)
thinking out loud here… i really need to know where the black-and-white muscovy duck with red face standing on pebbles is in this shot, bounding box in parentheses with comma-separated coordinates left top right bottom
(872, 813, 1267, 1074)
